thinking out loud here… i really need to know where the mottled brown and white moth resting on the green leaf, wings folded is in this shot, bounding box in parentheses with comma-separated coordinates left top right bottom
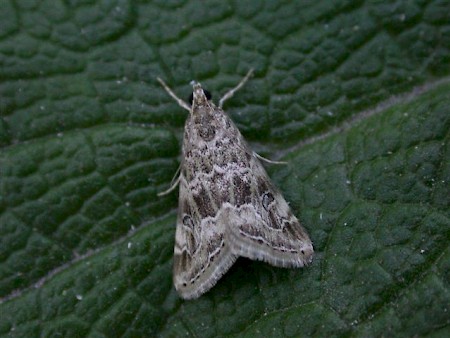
(158, 70, 314, 299)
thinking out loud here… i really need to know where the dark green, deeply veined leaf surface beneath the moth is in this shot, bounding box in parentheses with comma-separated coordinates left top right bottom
(0, 0, 450, 337)
